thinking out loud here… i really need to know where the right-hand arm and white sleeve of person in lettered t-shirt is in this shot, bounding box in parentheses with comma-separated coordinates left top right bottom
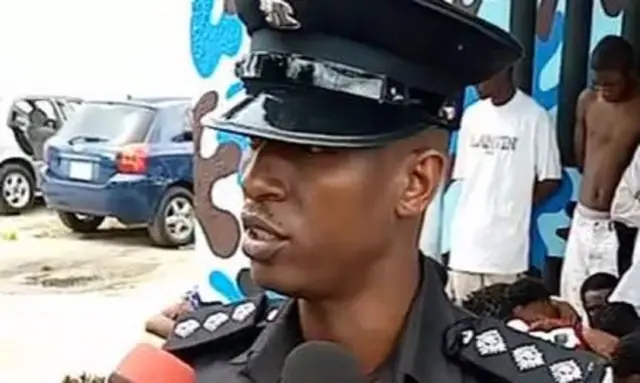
(533, 112, 562, 205)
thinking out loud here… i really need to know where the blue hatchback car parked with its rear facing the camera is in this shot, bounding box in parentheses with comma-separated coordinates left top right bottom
(42, 99, 195, 247)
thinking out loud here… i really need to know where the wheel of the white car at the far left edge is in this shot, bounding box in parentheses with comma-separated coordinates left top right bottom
(0, 164, 36, 214)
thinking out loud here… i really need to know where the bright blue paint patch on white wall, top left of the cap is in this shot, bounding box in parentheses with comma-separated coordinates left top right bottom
(190, 0, 244, 78)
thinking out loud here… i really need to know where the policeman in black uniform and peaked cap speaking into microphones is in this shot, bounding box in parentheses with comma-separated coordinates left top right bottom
(165, 0, 603, 383)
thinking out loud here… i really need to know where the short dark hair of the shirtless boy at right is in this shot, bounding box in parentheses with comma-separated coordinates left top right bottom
(591, 35, 635, 73)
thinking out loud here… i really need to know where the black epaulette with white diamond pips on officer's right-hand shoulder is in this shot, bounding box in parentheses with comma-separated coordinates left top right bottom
(445, 318, 607, 383)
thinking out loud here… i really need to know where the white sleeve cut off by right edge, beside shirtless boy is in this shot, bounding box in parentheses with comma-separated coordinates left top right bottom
(611, 149, 640, 227)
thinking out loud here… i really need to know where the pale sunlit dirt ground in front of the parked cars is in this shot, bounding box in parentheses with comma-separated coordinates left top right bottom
(0, 207, 196, 383)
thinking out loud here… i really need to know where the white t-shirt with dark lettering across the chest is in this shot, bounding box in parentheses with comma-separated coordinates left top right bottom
(449, 91, 562, 274)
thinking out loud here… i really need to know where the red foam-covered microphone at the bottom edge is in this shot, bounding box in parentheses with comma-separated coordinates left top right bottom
(107, 343, 196, 383)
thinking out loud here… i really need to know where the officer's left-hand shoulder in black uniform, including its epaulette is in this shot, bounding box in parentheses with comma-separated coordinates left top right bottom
(163, 295, 281, 363)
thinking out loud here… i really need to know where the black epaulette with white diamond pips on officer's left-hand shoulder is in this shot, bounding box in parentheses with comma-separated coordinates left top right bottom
(164, 295, 269, 351)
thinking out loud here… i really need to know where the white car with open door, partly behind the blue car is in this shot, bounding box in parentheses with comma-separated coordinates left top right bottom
(0, 95, 82, 215)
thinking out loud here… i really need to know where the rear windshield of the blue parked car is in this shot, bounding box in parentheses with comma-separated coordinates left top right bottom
(59, 103, 154, 144)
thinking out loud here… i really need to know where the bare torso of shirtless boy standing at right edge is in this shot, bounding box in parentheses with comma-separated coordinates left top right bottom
(580, 92, 640, 211)
